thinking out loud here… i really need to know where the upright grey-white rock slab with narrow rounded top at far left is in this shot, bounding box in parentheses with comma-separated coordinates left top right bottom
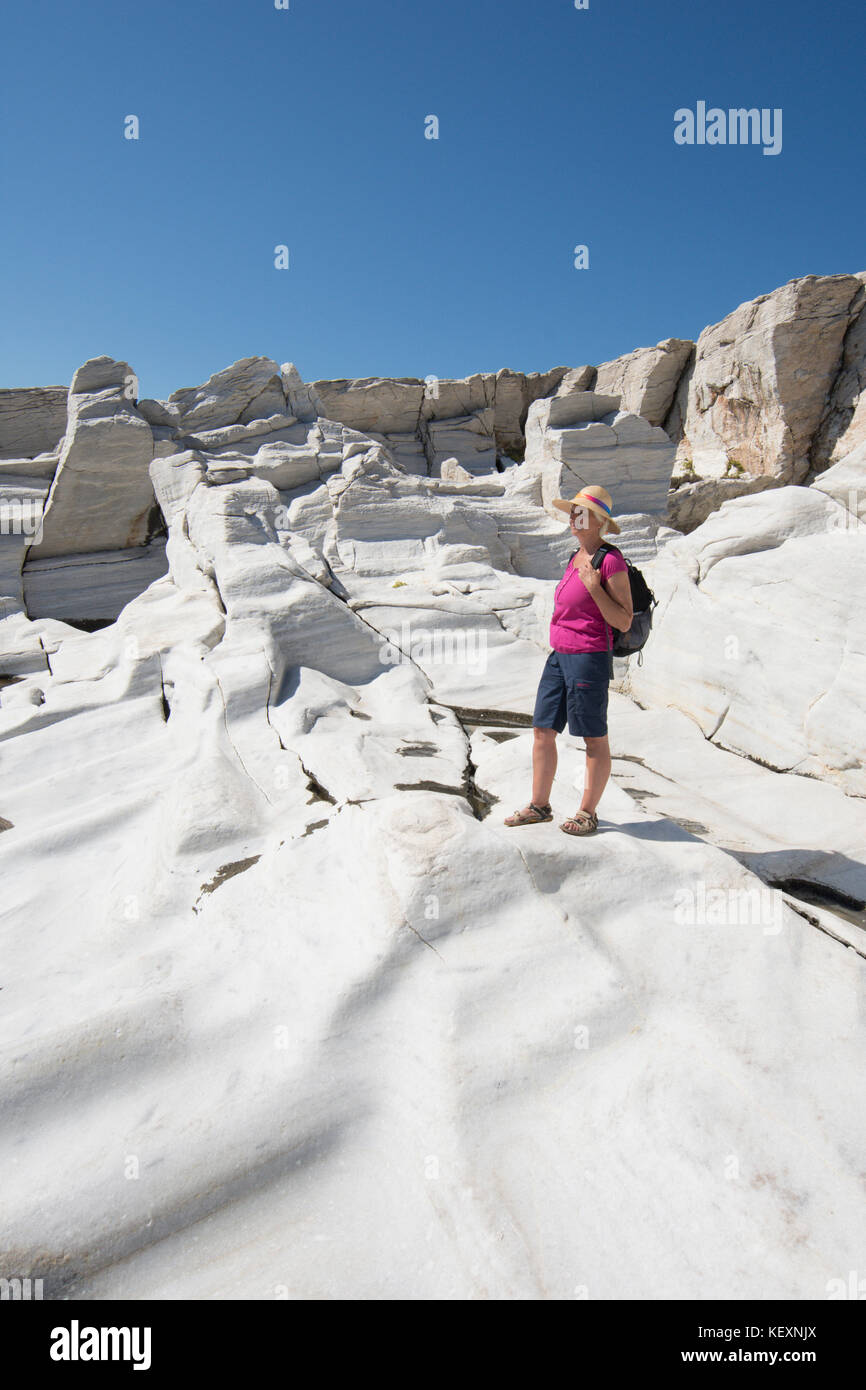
(28, 357, 154, 560)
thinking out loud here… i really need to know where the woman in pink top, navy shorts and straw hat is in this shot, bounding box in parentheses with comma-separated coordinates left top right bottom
(505, 484, 632, 835)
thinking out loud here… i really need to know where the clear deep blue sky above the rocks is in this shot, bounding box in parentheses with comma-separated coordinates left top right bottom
(0, 0, 866, 396)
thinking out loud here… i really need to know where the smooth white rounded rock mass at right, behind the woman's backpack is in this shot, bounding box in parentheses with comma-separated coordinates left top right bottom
(623, 475, 866, 796)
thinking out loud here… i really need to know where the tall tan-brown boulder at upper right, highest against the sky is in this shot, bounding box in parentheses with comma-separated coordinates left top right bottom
(666, 275, 863, 482)
